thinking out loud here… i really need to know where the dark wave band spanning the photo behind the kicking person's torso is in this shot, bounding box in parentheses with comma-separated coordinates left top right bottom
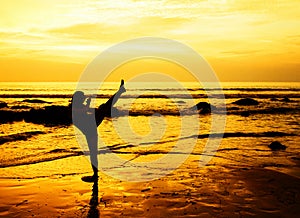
(0, 102, 300, 125)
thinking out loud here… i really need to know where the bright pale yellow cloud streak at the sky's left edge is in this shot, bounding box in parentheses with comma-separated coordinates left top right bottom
(0, 31, 99, 63)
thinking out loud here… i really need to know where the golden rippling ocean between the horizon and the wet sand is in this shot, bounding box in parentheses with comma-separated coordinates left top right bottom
(0, 82, 300, 180)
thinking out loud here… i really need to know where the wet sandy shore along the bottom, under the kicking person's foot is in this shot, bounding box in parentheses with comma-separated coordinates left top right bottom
(0, 154, 300, 217)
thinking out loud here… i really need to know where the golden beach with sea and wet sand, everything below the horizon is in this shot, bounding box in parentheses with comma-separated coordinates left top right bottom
(0, 83, 300, 217)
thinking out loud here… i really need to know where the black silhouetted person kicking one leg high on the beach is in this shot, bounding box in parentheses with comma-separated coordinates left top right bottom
(72, 80, 126, 181)
